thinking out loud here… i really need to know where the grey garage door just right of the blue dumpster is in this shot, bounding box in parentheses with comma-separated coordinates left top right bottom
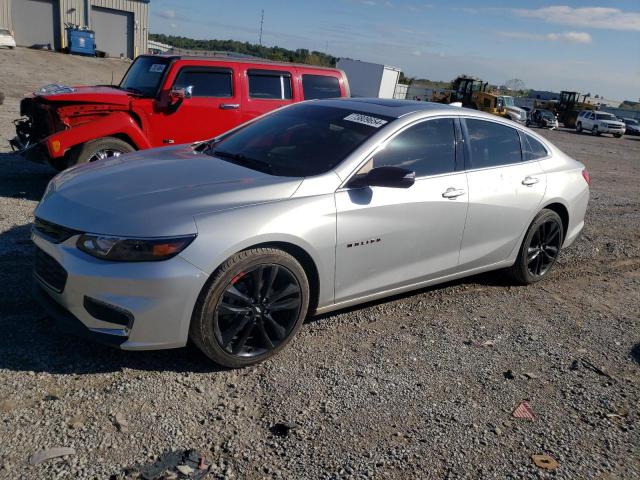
(91, 7, 133, 58)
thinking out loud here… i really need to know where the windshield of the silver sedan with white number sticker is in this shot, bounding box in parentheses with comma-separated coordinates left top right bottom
(208, 104, 393, 177)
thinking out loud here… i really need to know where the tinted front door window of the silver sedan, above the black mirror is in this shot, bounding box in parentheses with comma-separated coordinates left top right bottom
(368, 118, 456, 177)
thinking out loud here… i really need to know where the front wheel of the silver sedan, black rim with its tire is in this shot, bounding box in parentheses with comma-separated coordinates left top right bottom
(189, 248, 309, 368)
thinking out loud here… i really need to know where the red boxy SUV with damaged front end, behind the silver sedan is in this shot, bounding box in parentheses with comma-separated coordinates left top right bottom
(11, 55, 349, 170)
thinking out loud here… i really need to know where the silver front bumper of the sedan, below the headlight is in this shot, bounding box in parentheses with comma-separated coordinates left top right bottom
(32, 233, 207, 350)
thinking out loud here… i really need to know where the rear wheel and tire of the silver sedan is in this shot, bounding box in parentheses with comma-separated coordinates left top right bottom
(507, 209, 564, 285)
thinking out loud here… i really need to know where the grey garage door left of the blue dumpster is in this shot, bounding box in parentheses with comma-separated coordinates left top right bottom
(12, 0, 60, 49)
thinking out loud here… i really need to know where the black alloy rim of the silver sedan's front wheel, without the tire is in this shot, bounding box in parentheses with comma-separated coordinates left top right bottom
(213, 264, 302, 357)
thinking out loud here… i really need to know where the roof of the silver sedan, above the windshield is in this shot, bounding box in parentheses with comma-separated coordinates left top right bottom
(306, 98, 464, 118)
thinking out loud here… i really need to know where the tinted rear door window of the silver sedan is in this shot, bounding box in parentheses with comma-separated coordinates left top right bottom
(465, 118, 522, 168)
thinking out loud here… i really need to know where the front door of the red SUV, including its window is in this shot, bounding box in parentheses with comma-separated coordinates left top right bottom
(153, 65, 241, 145)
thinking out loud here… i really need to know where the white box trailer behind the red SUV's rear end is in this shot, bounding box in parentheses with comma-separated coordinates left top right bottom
(336, 58, 401, 98)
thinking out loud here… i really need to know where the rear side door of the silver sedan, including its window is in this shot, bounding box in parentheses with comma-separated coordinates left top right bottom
(460, 118, 546, 270)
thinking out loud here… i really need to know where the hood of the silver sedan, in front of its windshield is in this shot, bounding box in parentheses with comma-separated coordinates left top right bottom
(35, 146, 302, 237)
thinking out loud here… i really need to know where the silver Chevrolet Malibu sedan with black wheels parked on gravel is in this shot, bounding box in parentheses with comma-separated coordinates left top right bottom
(33, 99, 589, 367)
